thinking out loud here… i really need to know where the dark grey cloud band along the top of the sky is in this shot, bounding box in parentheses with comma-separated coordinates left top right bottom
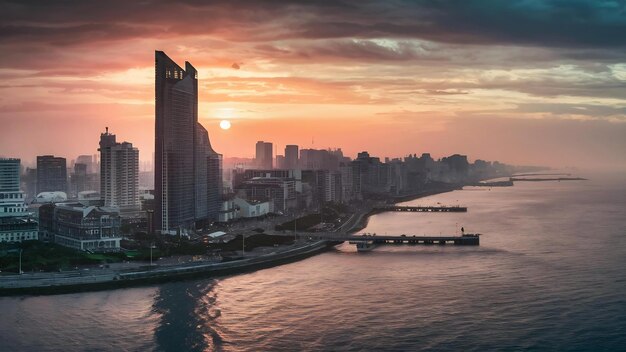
(0, 0, 626, 49)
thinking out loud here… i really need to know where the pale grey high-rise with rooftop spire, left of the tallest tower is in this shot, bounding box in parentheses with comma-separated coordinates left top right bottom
(98, 127, 140, 210)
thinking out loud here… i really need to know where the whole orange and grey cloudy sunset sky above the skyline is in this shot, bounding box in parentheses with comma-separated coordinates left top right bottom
(0, 0, 626, 169)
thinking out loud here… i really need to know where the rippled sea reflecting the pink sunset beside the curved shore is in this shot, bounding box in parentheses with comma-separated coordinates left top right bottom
(0, 174, 626, 352)
